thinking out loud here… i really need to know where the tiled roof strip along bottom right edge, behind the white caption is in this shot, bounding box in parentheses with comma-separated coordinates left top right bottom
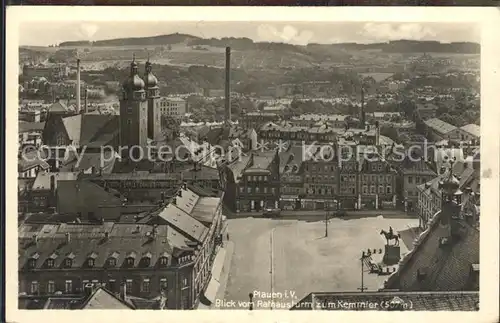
(292, 291, 479, 311)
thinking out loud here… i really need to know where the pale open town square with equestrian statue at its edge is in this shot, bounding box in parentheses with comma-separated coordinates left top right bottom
(224, 216, 418, 309)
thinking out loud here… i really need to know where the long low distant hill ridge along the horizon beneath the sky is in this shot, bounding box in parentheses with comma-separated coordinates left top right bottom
(59, 33, 480, 54)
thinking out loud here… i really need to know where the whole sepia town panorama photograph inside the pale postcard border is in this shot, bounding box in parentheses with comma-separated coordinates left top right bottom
(18, 22, 481, 311)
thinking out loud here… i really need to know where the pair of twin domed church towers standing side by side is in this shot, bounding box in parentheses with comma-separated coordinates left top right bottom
(119, 55, 162, 158)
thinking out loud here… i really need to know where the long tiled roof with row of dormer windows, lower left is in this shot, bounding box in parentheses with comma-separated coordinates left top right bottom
(18, 222, 189, 269)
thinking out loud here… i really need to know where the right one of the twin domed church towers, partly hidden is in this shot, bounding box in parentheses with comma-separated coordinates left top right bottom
(144, 58, 162, 140)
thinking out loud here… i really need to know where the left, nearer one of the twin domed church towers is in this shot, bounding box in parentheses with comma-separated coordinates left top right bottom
(120, 55, 148, 161)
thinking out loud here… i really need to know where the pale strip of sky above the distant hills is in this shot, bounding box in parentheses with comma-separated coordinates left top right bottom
(19, 21, 480, 46)
